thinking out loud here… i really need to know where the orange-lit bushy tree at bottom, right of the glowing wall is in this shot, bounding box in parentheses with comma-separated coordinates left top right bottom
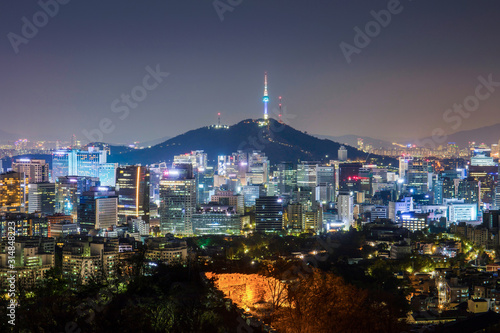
(272, 269, 402, 333)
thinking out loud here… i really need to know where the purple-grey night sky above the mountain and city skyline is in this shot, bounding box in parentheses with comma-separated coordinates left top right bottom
(0, 0, 500, 143)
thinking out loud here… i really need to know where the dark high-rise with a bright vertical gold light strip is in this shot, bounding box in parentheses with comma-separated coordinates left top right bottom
(116, 165, 150, 223)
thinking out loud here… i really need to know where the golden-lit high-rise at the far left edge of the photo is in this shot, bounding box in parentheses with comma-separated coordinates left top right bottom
(0, 171, 29, 212)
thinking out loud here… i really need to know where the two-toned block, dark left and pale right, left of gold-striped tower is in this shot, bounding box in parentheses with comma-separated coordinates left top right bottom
(78, 187, 118, 233)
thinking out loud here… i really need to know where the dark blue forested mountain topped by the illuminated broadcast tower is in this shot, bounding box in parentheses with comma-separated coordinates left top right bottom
(108, 119, 396, 165)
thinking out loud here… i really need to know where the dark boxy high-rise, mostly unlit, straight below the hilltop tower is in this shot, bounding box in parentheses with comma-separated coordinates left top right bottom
(255, 196, 283, 232)
